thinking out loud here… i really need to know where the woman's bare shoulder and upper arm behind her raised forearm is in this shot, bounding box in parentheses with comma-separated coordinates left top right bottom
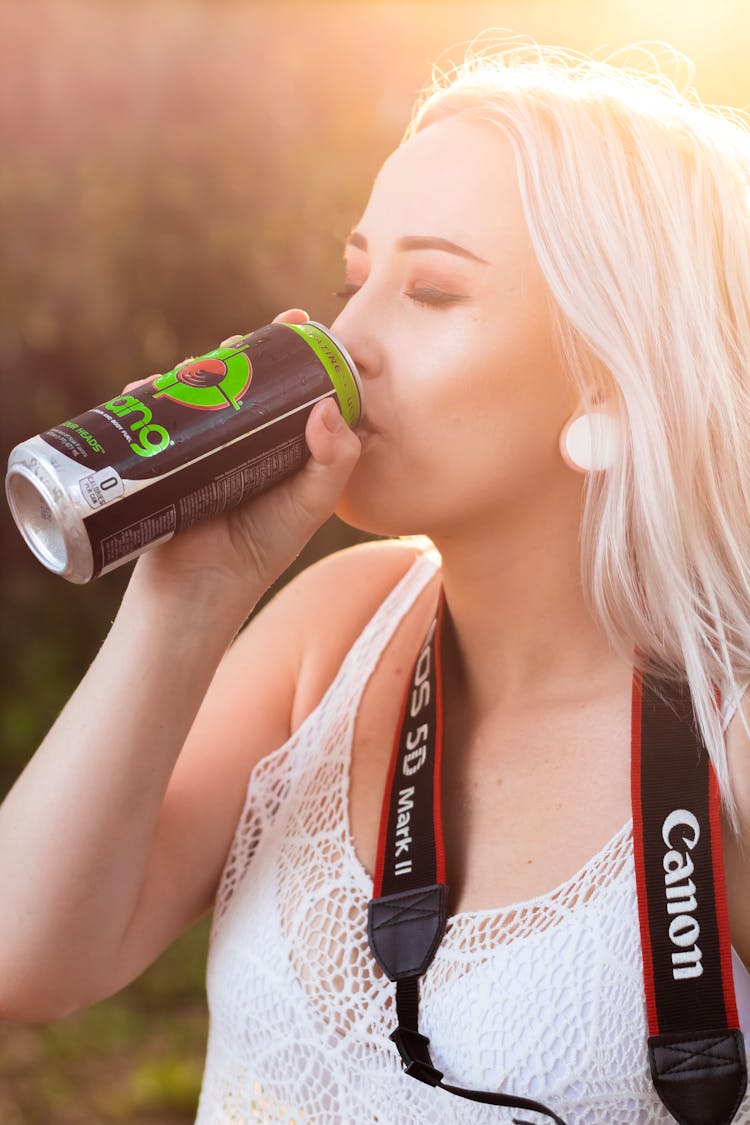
(118, 542, 418, 987)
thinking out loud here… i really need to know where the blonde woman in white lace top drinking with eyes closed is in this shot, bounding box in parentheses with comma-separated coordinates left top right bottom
(0, 42, 750, 1125)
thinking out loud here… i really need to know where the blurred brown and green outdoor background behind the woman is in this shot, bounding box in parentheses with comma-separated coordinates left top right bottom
(0, 0, 750, 1125)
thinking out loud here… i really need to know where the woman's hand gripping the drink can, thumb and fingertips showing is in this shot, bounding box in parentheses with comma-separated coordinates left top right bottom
(130, 309, 361, 601)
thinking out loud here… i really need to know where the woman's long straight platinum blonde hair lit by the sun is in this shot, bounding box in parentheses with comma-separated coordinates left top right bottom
(406, 36, 750, 830)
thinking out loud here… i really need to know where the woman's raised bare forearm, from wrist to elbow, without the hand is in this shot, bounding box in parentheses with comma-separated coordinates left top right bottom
(0, 574, 249, 1019)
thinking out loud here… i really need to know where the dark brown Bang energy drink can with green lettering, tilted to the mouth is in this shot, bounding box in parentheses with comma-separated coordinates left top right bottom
(6, 322, 362, 583)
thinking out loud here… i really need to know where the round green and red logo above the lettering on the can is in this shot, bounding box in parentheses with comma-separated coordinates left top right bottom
(154, 348, 253, 411)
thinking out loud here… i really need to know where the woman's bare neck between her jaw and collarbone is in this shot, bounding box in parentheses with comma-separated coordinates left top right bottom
(434, 501, 632, 716)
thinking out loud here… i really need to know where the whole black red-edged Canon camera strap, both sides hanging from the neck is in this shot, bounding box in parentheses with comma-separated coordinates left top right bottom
(368, 591, 747, 1125)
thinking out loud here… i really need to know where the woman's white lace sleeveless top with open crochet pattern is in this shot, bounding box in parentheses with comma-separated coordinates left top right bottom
(197, 555, 750, 1125)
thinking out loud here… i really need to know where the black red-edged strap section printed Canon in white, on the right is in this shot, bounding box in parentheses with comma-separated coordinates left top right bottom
(631, 675, 748, 1125)
